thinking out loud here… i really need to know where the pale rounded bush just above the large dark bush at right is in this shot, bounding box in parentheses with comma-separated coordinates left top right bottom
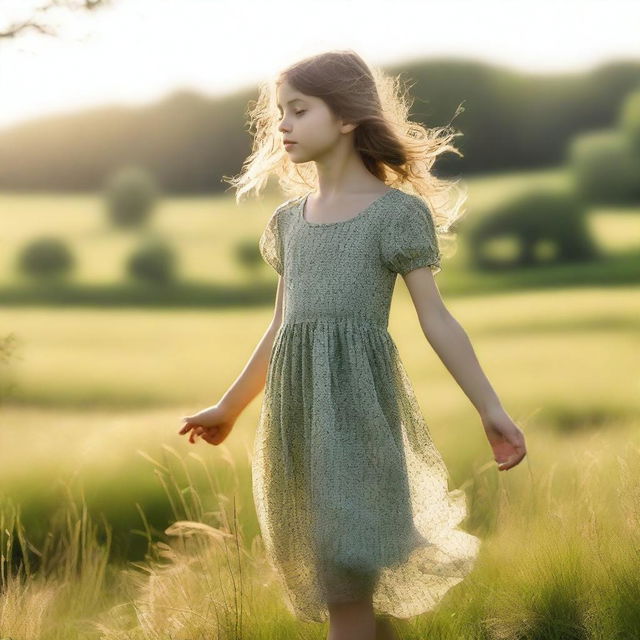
(569, 130, 640, 204)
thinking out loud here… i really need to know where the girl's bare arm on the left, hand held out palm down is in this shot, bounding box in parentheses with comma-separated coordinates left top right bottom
(178, 276, 284, 444)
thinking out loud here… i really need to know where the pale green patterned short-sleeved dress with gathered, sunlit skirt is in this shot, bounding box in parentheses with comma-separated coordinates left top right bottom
(252, 188, 480, 622)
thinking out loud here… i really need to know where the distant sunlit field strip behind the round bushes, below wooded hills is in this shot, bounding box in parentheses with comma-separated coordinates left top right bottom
(0, 169, 640, 293)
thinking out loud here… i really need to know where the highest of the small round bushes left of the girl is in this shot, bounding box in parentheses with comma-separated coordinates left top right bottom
(105, 167, 160, 228)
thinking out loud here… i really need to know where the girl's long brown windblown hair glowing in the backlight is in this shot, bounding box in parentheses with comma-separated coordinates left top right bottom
(225, 50, 466, 239)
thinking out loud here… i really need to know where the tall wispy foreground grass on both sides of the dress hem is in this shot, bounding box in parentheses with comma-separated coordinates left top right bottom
(0, 424, 640, 640)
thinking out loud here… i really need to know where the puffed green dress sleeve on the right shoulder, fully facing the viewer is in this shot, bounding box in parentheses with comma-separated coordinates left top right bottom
(381, 196, 442, 275)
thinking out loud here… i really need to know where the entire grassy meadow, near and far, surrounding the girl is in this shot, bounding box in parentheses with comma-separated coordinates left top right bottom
(0, 172, 640, 640)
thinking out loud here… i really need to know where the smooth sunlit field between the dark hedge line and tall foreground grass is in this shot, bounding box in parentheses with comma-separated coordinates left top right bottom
(0, 283, 640, 556)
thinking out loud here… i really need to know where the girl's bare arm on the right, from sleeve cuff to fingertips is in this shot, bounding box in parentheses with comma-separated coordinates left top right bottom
(403, 267, 526, 471)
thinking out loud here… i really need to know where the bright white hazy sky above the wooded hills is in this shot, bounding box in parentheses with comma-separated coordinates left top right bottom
(0, 0, 640, 128)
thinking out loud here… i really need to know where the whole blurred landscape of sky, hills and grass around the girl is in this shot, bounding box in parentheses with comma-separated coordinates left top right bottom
(0, 0, 640, 640)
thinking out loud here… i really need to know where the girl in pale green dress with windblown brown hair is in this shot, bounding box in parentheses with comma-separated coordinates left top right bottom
(180, 51, 525, 640)
